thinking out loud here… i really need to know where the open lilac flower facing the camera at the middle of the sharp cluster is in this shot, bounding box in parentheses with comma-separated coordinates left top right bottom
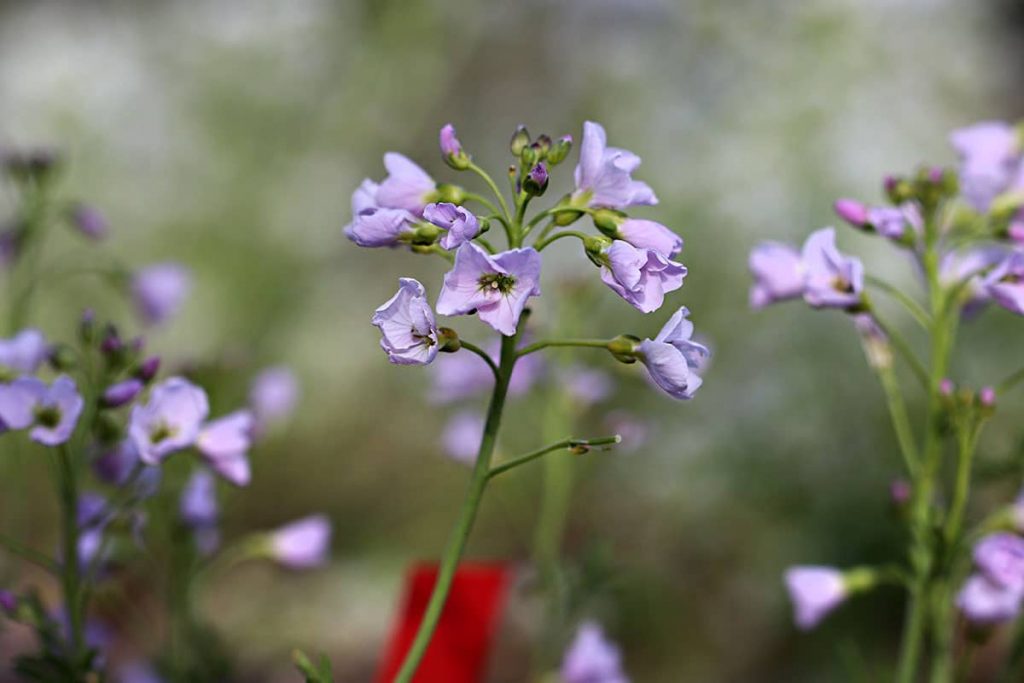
(437, 242, 541, 336)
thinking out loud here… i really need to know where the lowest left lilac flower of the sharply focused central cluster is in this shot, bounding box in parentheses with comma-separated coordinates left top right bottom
(371, 278, 440, 366)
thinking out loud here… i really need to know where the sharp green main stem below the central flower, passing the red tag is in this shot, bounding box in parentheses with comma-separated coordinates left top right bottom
(394, 335, 517, 683)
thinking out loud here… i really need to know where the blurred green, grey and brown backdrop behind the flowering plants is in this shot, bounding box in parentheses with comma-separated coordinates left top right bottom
(0, 0, 1024, 683)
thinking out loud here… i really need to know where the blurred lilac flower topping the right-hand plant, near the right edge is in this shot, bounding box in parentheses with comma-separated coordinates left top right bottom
(949, 121, 1021, 211)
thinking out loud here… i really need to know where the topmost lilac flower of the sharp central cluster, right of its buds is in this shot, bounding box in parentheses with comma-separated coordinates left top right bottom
(572, 121, 657, 209)
